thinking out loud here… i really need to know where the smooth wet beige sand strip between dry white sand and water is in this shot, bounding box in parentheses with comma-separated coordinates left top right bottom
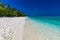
(23, 20, 43, 40)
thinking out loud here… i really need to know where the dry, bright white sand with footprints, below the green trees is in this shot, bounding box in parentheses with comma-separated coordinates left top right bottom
(0, 17, 26, 40)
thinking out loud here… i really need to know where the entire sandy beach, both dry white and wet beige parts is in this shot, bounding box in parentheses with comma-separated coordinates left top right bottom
(0, 17, 43, 40)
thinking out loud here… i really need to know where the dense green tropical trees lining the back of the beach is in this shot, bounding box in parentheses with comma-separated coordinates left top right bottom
(0, 2, 25, 17)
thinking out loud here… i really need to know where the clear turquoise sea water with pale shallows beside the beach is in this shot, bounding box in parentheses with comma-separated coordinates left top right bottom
(28, 16, 60, 40)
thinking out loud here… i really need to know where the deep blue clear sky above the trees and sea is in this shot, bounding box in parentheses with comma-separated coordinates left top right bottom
(2, 0, 60, 16)
